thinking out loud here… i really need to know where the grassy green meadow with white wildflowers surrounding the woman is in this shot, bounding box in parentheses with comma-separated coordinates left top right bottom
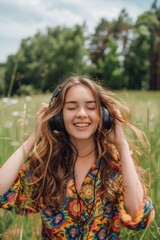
(0, 91, 160, 240)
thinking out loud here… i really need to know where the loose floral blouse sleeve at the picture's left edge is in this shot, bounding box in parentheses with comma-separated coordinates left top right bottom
(0, 166, 38, 215)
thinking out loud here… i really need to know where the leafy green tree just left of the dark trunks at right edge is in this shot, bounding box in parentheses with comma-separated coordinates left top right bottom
(124, 26, 150, 89)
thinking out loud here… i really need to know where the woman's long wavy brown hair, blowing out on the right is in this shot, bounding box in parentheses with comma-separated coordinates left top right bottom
(29, 76, 147, 208)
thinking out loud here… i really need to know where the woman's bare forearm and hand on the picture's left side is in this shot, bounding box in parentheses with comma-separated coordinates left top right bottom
(0, 104, 48, 195)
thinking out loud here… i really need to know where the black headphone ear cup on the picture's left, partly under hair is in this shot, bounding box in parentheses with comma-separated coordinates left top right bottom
(49, 111, 66, 132)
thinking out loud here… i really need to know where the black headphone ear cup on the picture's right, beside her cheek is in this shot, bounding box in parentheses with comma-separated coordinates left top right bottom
(101, 107, 113, 132)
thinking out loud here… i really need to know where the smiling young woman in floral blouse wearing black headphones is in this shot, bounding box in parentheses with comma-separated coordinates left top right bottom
(0, 76, 154, 240)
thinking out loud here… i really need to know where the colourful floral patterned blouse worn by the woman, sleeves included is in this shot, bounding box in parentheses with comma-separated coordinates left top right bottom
(0, 159, 154, 240)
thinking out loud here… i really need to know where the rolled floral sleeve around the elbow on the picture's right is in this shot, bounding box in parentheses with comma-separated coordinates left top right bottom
(118, 188, 155, 230)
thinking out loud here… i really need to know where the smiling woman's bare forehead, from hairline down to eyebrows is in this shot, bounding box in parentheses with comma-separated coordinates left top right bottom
(65, 84, 95, 102)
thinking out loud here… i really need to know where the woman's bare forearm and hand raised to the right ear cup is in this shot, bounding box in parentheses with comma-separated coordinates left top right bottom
(108, 120, 144, 218)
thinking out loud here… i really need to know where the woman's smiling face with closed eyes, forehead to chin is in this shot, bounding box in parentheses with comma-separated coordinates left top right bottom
(63, 84, 99, 142)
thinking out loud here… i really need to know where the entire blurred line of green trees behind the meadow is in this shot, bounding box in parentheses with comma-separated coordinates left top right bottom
(0, 0, 160, 96)
